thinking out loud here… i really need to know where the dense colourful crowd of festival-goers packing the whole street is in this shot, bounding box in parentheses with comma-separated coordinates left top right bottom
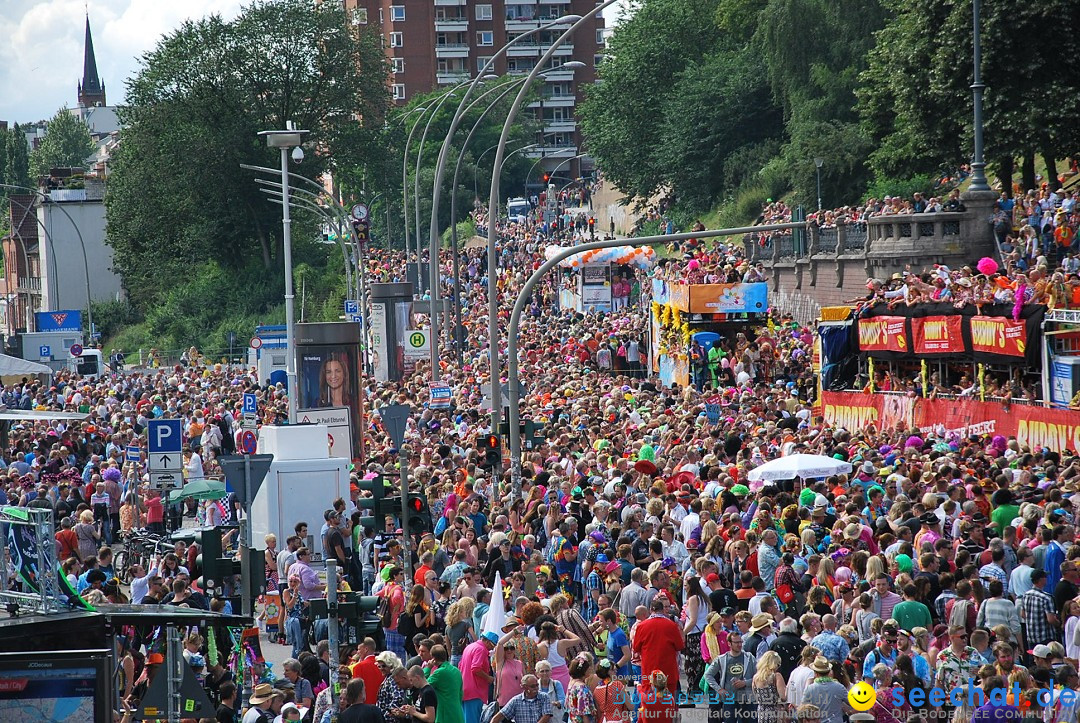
(6, 175, 1080, 723)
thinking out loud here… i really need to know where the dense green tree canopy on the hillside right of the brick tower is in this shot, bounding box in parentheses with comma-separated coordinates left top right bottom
(579, 0, 1080, 220)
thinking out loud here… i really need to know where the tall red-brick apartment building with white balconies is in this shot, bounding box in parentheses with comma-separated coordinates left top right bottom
(345, 0, 604, 183)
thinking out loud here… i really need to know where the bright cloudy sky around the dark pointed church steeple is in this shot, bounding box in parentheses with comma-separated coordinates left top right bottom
(0, 0, 243, 123)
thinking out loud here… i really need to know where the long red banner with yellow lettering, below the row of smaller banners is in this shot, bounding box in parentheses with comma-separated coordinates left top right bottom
(822, 391, 1080, 452)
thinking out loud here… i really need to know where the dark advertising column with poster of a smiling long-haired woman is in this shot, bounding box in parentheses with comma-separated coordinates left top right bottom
(296, 321, 362, 459)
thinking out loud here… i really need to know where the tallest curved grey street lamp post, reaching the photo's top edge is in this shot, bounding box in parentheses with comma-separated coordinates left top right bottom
(487, 0, 618, 427)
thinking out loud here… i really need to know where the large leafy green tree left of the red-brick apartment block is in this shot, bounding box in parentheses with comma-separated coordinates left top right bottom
(106, 0, 389, 309)
